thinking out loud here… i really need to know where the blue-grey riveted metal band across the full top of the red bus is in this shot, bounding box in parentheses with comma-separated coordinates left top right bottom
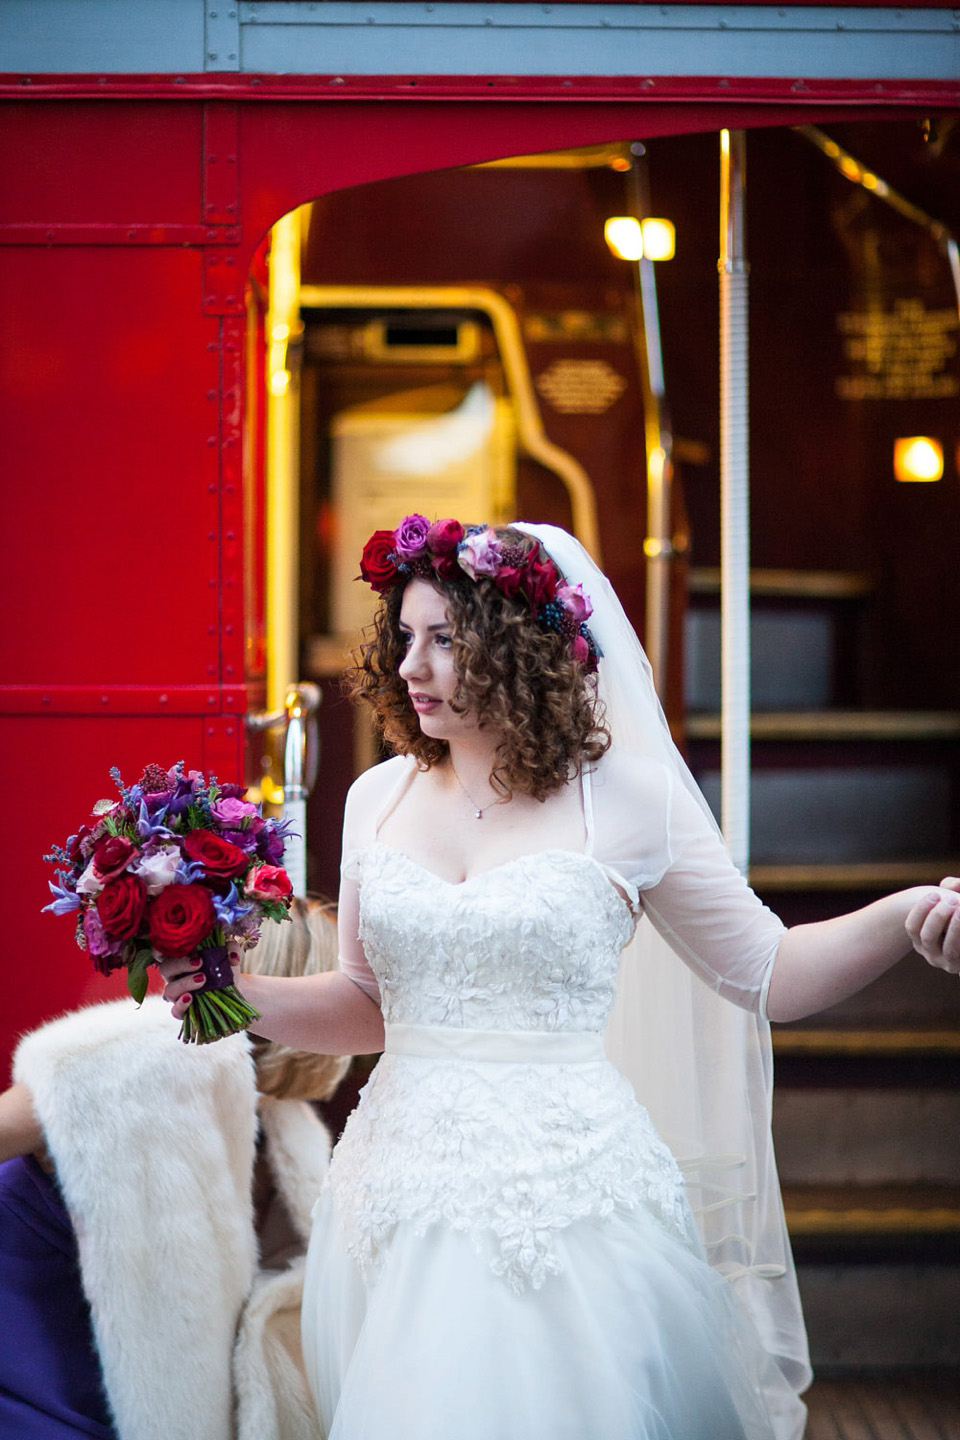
(0, 0, 960, 79)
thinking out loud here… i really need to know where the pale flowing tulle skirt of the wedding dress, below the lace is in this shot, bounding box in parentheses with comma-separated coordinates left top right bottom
(302, 1194, 797, 1440)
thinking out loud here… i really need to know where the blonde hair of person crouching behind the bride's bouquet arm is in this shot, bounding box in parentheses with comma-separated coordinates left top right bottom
(243, 896, 350, 1100)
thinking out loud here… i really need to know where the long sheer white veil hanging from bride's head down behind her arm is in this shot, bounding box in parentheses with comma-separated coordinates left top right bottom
(517, 524, 810, 1440)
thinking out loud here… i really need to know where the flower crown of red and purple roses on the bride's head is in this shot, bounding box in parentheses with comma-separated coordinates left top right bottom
(360, 516, 600, 672)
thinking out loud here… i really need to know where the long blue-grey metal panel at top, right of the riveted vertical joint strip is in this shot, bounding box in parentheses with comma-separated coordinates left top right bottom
(240, 0, 960, 79)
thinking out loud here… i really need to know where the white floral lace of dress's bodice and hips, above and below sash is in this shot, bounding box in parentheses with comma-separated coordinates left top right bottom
(330, 842, 691, 1290)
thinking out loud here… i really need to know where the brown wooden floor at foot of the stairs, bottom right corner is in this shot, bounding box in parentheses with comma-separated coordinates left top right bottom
(803, 1371, 960, 1440)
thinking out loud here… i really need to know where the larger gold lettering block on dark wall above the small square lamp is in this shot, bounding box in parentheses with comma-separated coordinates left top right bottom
(836, 300, 960, 400)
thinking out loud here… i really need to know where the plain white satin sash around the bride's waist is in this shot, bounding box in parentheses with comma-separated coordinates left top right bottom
(383, 1025, 604, 1066)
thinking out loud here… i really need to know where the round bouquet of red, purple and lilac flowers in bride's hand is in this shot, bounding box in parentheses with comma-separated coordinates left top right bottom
(43, 762, 292, 1045)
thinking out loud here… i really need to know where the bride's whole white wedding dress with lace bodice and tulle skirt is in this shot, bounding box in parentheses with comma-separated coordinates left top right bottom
(302, 759, 805, 1440)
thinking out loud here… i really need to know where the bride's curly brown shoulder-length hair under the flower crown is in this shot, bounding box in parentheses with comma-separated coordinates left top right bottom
(347, 527, 610, 801)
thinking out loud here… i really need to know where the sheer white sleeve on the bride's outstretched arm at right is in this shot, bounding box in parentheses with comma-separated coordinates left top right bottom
(593, 756, 786, 1014)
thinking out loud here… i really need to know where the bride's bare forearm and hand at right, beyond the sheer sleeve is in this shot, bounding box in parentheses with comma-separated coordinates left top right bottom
(767, 876, 960, 1021)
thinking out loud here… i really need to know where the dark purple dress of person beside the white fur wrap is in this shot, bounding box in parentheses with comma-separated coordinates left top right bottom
(0, 1156, 117, 1440)
